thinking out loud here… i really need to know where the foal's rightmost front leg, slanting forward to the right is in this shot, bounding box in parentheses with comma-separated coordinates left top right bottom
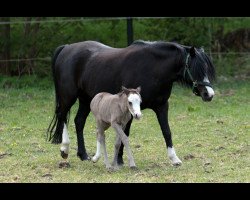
(111, 123, 136, 168)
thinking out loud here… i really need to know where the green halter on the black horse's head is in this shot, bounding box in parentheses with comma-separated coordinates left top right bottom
(183, 53, 212, 96)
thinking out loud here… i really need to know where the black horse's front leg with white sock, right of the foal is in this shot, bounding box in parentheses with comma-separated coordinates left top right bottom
(153, 102, 182, 165)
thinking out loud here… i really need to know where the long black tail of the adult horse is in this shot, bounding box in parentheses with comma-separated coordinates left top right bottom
(47, 45, 65, 144)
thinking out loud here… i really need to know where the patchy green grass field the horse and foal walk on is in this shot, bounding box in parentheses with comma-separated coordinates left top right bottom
(0, 79, 250, 183)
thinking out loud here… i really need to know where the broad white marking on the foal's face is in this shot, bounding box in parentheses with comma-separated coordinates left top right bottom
(128, 94, 142, 119)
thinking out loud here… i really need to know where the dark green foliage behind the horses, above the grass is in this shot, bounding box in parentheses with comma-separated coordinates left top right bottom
(0, 17, 250, 76)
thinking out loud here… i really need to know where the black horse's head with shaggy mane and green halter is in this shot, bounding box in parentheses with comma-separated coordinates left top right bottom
(183, 47, 215, 101)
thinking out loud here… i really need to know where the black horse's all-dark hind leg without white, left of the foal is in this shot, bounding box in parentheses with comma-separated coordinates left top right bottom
(75, 98, 90, 160)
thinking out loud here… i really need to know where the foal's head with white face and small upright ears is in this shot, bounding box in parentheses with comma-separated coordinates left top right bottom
(122, 86, 142, 119)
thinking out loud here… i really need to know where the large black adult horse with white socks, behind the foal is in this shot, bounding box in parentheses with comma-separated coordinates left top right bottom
(48, 41, 215, 165)
